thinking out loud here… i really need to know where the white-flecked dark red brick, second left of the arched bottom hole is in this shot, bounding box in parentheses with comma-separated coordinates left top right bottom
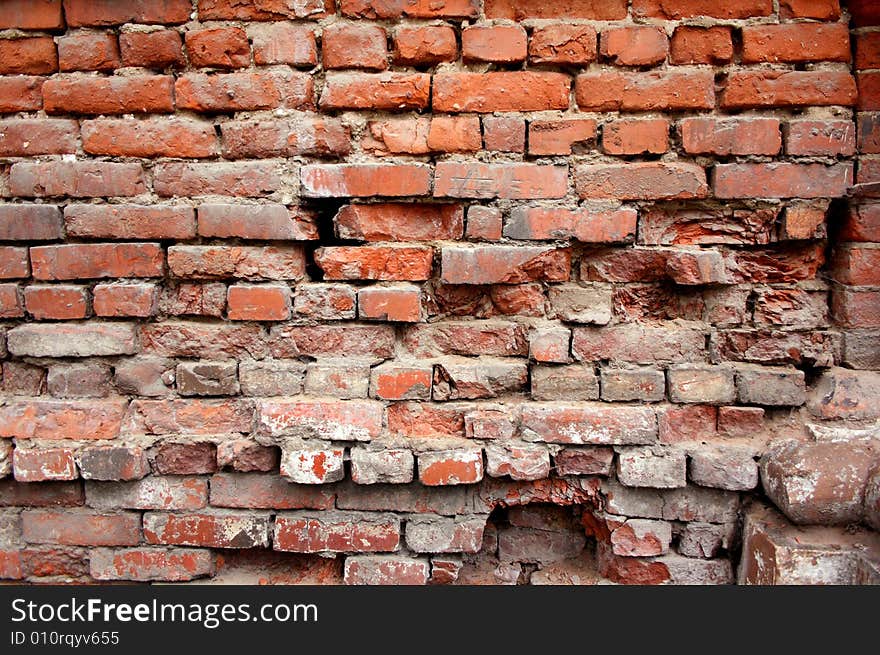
(272, 512, 400, 553)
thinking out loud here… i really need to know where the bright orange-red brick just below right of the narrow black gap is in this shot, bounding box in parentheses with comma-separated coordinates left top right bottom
(315, 246, 434, 281)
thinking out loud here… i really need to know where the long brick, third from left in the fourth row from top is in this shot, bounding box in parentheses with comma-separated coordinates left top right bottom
(220, 118, 351, 159)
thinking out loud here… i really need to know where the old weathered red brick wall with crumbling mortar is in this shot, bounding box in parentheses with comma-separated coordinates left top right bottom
(0, 0, 880, 584)
